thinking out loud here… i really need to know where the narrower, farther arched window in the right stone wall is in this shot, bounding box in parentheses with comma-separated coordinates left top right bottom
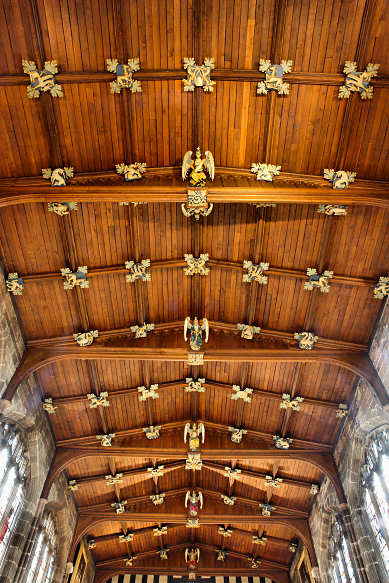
(330, 520, 357, 583)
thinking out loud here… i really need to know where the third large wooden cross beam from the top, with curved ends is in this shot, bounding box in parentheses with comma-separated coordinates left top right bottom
(41, 446, 345, 503)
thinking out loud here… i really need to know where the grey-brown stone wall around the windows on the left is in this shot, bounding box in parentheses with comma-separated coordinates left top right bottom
(0, 269, 85, 583)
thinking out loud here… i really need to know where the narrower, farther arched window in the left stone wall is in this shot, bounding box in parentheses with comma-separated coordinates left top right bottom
(26, 514, 56, 583)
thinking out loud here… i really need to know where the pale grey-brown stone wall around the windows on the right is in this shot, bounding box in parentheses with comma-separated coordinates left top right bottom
(291, 302, 389, 583)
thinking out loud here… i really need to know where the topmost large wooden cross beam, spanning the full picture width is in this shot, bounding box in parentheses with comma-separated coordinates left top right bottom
(0, 167, 389, 208)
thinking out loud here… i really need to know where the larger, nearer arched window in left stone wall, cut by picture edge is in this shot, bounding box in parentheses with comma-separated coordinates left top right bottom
(0, 423, 27, 569)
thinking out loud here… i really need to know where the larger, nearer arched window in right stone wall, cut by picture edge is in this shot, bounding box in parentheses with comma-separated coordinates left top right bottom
(362, 430, 389, 575)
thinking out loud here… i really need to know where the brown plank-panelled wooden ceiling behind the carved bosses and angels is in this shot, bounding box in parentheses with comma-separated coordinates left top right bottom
(0, 0, 389, 582)
